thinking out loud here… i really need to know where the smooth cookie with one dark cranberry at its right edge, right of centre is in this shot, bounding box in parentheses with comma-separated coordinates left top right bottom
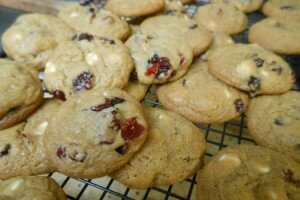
(156, 60, 248, 124)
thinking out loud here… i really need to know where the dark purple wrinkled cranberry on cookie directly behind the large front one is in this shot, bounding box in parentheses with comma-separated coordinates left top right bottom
(73, 72, 94, 92)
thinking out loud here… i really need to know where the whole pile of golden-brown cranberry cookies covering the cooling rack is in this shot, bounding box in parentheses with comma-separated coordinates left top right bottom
(0, 0, 300, 199)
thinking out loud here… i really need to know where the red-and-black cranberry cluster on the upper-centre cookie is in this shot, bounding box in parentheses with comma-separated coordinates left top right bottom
(145, 54, 172, 78)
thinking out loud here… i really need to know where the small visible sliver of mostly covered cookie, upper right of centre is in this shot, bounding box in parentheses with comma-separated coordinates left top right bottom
(201, 32, 235, 60)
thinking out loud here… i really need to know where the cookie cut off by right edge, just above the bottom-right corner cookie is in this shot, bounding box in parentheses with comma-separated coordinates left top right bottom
(247, 91, 300, 163)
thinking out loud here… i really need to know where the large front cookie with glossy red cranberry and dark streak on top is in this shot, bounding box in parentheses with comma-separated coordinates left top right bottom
(44, 88, 147, 178)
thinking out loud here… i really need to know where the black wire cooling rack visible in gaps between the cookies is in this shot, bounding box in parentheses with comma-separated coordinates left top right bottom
(0, 0, 300, 200)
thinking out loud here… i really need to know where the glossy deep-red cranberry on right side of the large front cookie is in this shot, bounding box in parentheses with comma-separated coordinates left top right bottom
(121, 117, 145, 140)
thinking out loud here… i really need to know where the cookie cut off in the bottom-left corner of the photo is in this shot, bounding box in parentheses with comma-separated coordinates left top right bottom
(0, 176, 67, 200)
